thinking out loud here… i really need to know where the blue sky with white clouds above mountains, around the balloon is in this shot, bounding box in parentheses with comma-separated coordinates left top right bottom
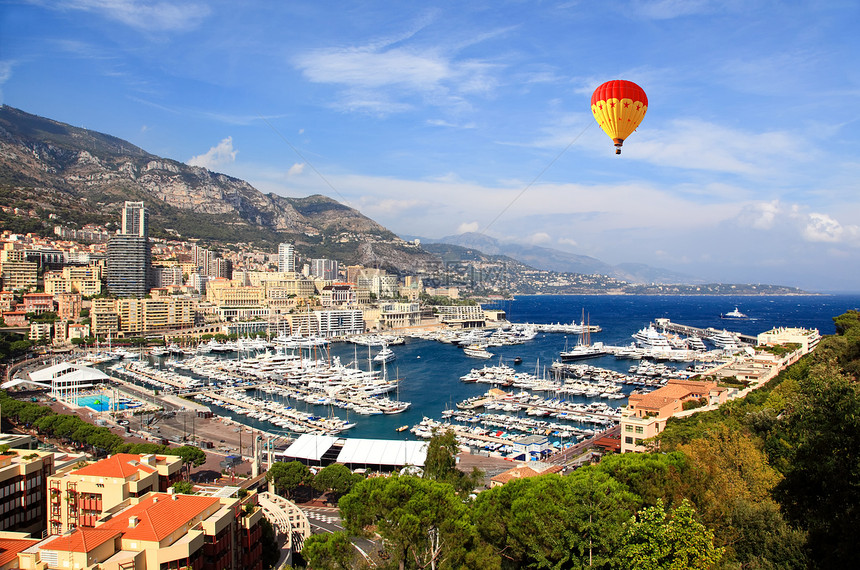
(0, 0, 860, 291)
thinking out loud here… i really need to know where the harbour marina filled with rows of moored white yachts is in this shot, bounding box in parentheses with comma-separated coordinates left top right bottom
(69, 296, 860, 453)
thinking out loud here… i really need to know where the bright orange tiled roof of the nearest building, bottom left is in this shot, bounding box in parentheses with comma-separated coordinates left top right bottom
(99, 493, 221, 542)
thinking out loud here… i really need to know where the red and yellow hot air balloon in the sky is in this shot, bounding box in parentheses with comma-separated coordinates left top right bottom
(591, 79, 648, 154)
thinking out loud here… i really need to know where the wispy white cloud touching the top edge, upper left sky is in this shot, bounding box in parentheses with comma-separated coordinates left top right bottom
(55, 0, 210, 32)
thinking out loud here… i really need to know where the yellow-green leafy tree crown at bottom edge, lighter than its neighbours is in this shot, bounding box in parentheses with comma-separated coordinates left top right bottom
(618, 500, 723, 570)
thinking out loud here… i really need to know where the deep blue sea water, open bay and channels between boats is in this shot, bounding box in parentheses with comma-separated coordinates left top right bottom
(185, 294, 860, 440)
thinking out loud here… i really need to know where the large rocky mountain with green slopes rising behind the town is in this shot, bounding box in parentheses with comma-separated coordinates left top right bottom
(0, 105, 434, 269)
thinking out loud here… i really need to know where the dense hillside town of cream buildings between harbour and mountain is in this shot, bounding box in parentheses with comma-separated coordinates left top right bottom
(0, 202, 508, 345)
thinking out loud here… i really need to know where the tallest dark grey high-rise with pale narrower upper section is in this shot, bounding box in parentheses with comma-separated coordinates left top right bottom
(107, 202, 152, 297)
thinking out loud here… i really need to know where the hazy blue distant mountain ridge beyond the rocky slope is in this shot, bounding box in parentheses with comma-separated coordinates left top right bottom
(420, 232, 698, 283)
